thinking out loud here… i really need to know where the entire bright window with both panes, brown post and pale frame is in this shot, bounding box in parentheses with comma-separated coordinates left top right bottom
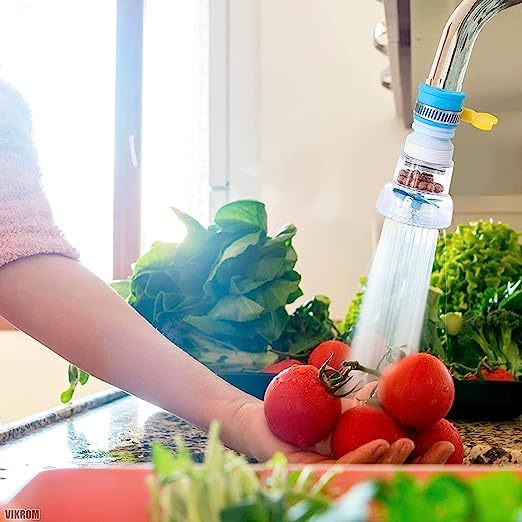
(0, 0, 257, 281)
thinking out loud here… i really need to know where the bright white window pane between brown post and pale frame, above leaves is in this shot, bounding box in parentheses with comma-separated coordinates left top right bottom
(142, 0, 211, 249)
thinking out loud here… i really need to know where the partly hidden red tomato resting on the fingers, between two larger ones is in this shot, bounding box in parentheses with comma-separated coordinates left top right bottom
(331, 404, 406, 459)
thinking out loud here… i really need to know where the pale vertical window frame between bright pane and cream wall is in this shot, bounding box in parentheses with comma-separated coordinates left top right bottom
(209, 0, 261, 216)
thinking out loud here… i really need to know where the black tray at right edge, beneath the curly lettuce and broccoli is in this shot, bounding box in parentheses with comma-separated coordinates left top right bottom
(448, 380, 522, 421)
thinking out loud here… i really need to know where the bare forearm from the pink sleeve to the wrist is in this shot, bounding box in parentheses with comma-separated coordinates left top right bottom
(0, 255, 257, 456)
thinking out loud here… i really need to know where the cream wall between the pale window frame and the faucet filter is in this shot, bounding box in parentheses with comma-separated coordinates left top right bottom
(254, 0, 407, 317)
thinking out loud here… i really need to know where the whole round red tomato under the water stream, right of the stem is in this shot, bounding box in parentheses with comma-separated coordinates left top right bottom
(377, 353, 455, 430)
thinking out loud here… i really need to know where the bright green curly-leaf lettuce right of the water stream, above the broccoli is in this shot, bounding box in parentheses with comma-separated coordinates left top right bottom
(431, 219, 522, 312)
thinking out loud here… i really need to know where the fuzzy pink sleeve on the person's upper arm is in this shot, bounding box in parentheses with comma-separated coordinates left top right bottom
(0, 81, 78, 266)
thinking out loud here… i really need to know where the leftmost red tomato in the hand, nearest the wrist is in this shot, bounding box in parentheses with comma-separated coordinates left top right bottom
(264, 364, 341, 449)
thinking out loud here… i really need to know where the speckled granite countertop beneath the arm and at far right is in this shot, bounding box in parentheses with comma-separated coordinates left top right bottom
(0, 391, 522, 502)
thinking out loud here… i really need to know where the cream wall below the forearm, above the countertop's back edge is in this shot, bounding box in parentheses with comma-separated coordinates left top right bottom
(0, 331, 108, 425)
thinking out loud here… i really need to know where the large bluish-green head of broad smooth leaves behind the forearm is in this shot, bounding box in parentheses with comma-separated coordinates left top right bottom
(128, 201, 302, 371)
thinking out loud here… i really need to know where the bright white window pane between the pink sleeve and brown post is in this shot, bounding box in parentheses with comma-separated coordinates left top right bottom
(0, 0, 116, 280)
